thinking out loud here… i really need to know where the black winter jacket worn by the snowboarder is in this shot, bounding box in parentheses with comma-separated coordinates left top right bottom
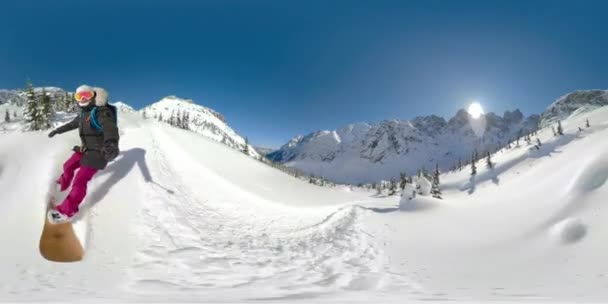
(55, 106, 119, 170)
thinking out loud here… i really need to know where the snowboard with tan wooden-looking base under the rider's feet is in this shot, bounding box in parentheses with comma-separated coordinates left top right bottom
(38, 182, 85, 263)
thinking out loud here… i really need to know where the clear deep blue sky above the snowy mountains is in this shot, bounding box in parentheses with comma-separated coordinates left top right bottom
(0, 0, 608, 146)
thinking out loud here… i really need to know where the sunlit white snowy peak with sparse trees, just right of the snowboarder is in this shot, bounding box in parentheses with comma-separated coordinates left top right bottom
(139, 96, 260, 158)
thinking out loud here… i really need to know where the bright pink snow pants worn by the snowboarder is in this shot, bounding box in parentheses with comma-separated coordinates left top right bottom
(57, 152, 97, 217)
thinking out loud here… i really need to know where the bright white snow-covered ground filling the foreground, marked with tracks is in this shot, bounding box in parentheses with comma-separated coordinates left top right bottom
(0, 96, 608, 303)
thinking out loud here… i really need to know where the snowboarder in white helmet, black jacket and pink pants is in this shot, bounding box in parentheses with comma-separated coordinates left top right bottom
(47, 85, 119, 223)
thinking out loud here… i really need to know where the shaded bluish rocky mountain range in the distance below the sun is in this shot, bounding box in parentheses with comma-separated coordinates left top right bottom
(268, 110, 539, 183)
